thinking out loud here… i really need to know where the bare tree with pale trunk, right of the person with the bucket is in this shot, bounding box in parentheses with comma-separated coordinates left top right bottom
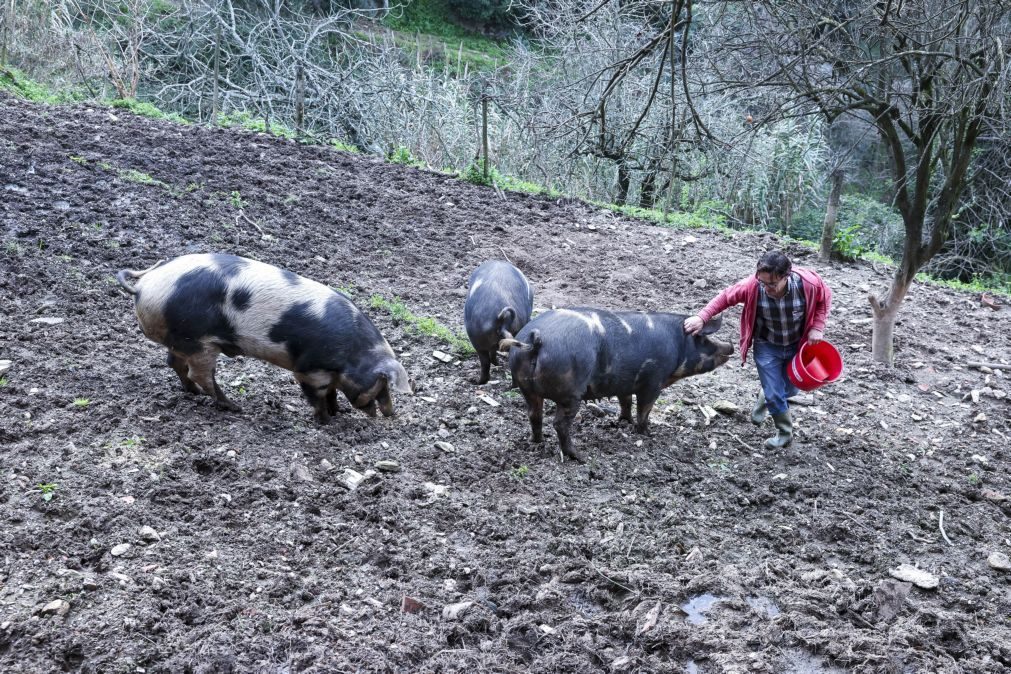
(712, 0, 1011, 364)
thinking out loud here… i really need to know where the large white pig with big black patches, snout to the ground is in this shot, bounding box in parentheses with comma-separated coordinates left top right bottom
(117, 254, 411, 423)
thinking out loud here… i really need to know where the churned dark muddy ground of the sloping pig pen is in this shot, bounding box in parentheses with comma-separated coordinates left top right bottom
(0, 96, 1011, 673)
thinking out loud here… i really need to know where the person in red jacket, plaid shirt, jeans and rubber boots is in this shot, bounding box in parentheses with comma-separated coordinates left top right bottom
(684, 251, 832, 449)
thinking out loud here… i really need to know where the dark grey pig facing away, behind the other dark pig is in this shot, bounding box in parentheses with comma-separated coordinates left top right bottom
(463, 260, 534, 384)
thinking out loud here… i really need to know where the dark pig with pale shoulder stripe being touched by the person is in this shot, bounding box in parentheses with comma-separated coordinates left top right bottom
(502, 307, 734, 462)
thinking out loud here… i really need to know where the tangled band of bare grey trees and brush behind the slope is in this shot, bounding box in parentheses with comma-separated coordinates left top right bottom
(2, 0, 1011, 335)
